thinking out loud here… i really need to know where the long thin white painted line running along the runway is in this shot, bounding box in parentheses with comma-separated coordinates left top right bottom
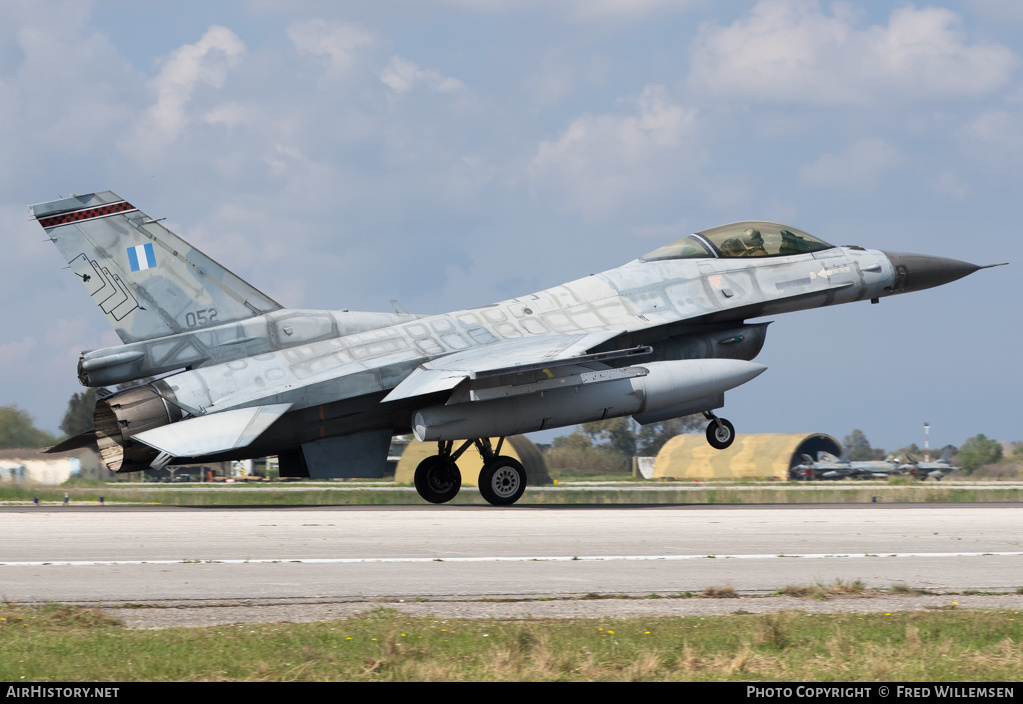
(7, 553, 1023, 567)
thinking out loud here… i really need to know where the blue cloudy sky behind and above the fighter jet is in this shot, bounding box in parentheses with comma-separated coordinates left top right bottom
(0, 0, 1023, 448)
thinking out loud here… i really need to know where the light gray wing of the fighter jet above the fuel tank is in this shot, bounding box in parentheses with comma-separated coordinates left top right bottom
(384, 331, 651, 401)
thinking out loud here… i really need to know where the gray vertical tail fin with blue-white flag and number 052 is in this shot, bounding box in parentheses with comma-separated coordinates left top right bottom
(29, 190, 281, 343)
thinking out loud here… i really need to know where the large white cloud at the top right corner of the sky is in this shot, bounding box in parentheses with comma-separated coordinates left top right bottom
(690, 0, 1019, 105)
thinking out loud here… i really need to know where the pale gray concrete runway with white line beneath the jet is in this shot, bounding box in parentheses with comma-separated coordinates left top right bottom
(0, 504, 1023, 604)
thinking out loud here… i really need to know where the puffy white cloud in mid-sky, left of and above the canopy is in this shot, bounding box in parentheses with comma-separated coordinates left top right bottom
(530, 86, 698, 218)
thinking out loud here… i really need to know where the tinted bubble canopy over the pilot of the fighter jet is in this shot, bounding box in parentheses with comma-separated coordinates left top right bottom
(641, 220, 834, 262)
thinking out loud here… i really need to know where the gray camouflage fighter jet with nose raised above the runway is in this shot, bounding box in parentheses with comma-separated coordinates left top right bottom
(29, 191, 998, 504)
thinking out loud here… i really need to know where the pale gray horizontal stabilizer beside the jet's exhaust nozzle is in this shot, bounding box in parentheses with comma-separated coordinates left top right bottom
(132, 403, 292, 457)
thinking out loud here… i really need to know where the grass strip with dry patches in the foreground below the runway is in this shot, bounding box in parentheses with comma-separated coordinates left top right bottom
(0, 605, 1023, 683)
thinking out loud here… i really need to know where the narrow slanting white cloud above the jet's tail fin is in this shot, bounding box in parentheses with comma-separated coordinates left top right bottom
(134, 26, 246, 150)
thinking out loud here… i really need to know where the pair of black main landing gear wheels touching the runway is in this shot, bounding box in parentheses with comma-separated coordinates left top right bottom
(415, 438, 526, 505)
